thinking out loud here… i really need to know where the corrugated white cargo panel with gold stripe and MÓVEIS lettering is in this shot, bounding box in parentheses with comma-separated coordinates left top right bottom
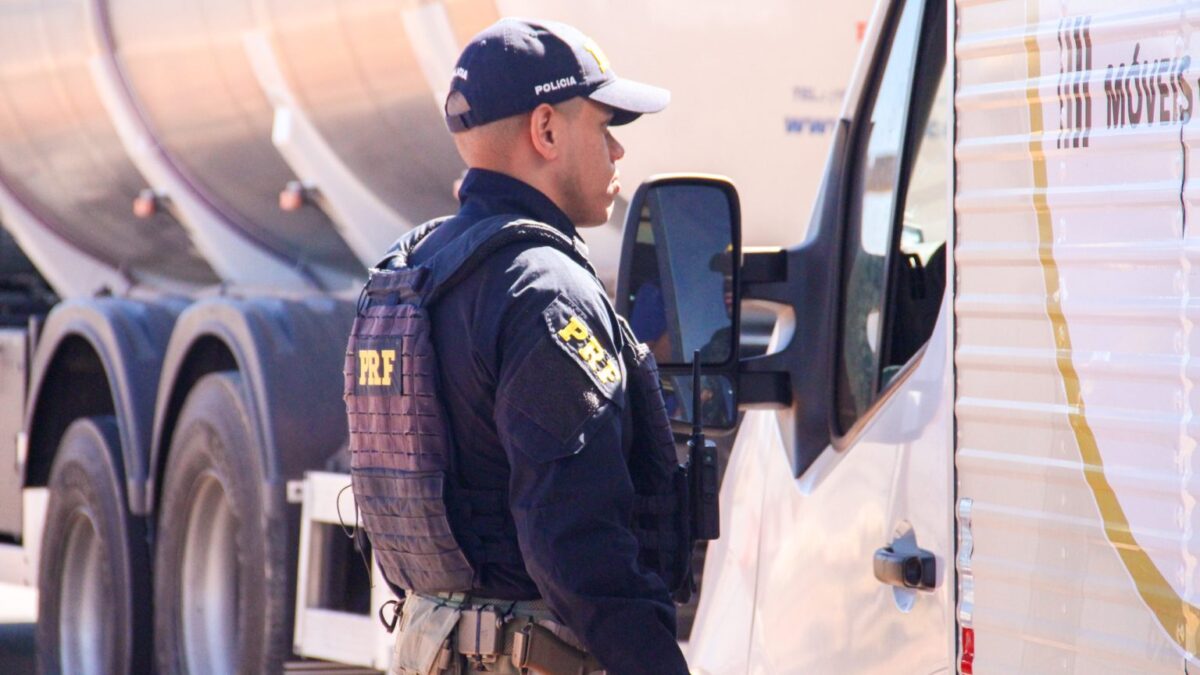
(955, 0, 1200, 674)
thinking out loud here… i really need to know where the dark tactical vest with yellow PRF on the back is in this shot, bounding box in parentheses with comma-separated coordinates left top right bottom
(344, 216, 691, 593)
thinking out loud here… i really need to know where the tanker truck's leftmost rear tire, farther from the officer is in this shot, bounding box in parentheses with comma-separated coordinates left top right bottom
(36, 417, 152, 675)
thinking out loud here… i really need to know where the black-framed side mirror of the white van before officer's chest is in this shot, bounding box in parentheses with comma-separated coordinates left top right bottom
(617, 175, 742, 429)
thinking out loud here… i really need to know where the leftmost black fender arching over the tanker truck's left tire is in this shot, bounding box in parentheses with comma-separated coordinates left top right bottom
(24, 298, 186, 512)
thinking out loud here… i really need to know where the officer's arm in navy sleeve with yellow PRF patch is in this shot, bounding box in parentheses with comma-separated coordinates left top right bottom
(496, 251, 688, 675)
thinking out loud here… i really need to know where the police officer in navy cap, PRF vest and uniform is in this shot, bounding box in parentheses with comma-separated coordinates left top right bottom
(346, 19, 690, 675)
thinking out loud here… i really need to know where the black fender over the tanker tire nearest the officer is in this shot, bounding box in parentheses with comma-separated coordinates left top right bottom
(143, 297, 354, 514)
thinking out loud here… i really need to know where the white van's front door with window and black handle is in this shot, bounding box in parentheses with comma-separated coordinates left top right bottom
(731, 0, 955, 674)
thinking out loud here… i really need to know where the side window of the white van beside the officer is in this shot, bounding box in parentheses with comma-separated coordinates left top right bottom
(835, 0, 949, 432)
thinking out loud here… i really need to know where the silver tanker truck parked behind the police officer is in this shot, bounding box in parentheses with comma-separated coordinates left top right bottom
(0, 0, 869, 673)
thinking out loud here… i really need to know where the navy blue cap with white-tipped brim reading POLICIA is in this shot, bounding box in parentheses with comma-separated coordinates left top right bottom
(445, 18, 671, 132)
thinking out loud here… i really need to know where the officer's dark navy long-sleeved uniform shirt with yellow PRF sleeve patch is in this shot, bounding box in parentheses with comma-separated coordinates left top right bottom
(398, 169, 686, 675)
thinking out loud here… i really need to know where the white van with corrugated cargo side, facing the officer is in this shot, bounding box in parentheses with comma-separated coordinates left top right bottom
(618, 0, 1200, 674)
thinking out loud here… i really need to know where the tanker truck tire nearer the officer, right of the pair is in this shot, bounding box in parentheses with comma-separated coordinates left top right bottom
(154, 372, 290, 675)
